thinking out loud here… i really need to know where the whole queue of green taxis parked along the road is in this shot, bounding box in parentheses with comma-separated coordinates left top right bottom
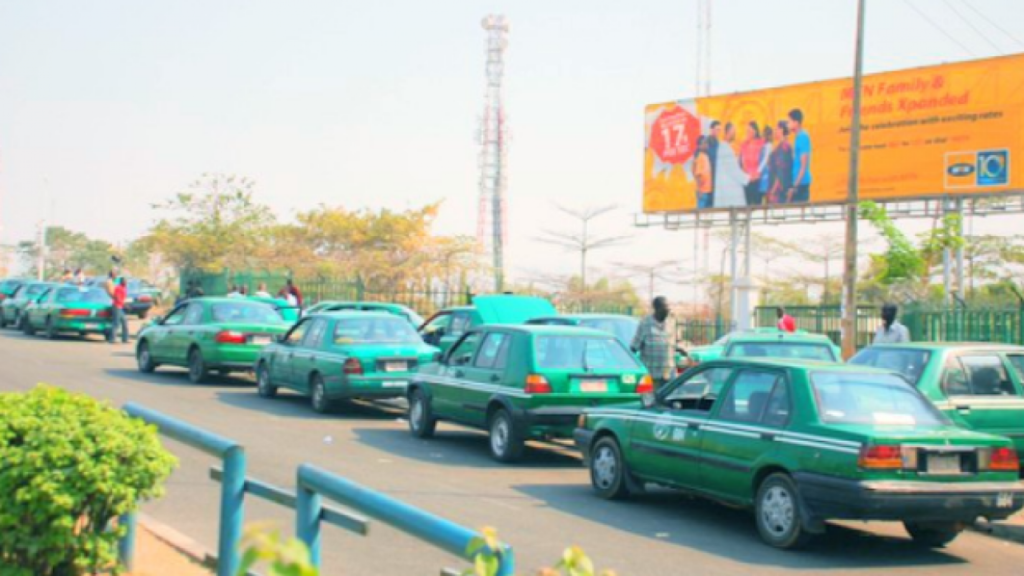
(0, 280, 1024, 548)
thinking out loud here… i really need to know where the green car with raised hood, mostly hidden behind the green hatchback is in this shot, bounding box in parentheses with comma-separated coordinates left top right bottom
(420, 294, 557, 351)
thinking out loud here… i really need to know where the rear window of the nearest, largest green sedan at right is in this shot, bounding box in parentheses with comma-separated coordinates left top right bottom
(811, 372, 949, 427)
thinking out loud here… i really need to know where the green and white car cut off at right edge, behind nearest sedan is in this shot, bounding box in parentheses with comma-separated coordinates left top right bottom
(850, 342, 1024, 463)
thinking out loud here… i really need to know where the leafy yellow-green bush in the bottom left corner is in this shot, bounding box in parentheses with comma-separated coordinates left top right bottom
(0, 385, 176, 576)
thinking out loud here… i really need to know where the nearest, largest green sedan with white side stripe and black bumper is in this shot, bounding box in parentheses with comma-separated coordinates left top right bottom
(575, 360, 1024, 548)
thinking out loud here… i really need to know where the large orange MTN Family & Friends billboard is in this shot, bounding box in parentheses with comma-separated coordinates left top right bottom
(643, 54, 1024, 213)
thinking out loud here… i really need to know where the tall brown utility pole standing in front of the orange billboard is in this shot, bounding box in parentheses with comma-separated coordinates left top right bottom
(843, 0, 866, 358)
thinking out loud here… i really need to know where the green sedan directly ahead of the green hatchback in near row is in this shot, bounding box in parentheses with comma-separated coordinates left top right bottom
(256, 312, 437, 413)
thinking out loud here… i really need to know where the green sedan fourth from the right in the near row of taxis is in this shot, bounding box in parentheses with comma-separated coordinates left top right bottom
(135, 298, 291, 383)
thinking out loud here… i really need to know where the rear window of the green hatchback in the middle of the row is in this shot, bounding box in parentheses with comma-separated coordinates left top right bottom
(534, 336, 640, 372)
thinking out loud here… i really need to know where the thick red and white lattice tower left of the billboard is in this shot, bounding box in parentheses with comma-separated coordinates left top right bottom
(476, 14, 509, 292)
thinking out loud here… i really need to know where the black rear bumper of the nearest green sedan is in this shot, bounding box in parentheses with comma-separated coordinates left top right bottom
(794, 472, 1024, 523)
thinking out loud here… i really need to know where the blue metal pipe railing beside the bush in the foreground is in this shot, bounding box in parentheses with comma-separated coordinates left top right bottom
(118, 403, 515, 576)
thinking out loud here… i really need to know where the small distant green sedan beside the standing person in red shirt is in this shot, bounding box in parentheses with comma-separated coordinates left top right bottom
(23, 286, 113, 339)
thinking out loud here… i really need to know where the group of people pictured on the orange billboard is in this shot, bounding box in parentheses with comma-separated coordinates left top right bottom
(692, 109, 811, 209)
